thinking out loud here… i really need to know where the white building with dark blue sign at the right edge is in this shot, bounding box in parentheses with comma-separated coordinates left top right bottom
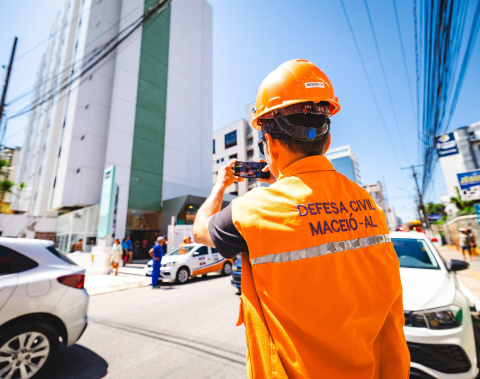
(436, 122, 480, 198)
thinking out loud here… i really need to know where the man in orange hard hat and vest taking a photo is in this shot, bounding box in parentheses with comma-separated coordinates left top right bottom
(193, 60, 410, 379)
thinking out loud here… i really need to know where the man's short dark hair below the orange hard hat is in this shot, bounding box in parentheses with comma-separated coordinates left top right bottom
(261, 113, 330, 157)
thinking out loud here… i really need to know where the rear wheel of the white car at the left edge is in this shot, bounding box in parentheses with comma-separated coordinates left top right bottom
(0, 323, 59, 379)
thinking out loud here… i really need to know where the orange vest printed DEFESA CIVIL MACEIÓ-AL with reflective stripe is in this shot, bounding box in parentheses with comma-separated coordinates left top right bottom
(232, 156, 410, 379)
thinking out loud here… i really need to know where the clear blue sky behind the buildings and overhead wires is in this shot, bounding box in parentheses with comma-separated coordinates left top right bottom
(0, 0, 480, 222)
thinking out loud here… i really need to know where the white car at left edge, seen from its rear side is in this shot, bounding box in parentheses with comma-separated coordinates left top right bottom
(0, 237, 88, 379)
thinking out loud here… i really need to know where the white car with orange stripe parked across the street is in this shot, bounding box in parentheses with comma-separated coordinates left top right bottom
(145, 243, 232, 283)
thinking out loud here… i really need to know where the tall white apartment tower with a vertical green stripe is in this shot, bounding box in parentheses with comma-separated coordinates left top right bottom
(15, 0, 212, 249)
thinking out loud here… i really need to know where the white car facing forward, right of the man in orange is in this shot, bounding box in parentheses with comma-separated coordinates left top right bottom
(391, 232, 478, 379)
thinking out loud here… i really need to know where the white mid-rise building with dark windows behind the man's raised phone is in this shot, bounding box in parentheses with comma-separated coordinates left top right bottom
(213, 103, 265, 196)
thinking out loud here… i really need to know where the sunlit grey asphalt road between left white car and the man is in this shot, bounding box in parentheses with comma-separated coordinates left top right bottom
(49, 275, 246, 379)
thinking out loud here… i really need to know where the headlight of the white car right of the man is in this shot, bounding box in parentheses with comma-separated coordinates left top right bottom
(405, 304, 463, 329)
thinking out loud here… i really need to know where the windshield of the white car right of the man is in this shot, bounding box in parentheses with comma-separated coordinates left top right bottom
(392, 238, 440, 270)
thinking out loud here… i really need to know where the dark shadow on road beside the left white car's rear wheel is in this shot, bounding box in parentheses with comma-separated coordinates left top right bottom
(47, 344, 108, 379)
